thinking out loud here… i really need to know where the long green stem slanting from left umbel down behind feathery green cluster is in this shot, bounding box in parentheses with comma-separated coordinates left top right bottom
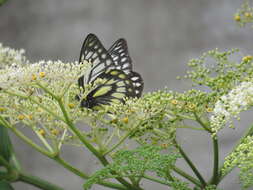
(57, 99, 140, 190)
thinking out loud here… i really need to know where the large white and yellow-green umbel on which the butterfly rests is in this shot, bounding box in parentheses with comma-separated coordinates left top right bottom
(0, 43, 180, 154)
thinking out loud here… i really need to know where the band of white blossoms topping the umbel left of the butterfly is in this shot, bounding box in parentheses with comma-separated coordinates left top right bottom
(0, 61, 85, 89)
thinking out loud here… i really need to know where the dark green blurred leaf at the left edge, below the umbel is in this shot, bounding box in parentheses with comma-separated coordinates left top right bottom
(0, 125, 13, 162)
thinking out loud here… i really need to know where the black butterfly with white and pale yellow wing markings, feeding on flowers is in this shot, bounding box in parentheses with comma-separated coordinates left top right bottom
(78, 34, 144, 109)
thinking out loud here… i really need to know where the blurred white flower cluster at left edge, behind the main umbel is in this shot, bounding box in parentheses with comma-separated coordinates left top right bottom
(0, 43, 28, 69)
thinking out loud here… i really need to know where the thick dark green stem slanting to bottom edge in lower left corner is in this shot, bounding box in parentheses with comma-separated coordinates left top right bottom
(17, 172, 63, 190)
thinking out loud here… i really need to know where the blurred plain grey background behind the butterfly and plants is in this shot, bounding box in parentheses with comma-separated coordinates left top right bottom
(0, 0, 253, 190)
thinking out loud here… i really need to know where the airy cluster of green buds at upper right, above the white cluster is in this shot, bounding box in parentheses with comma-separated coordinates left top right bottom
(182, 49, 253, 95)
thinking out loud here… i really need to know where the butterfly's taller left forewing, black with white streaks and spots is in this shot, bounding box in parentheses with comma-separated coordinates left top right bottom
(78, 34, 113, 87)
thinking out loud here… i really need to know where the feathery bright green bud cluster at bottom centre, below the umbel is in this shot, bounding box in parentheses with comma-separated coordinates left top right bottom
(84, 145, 182, 189)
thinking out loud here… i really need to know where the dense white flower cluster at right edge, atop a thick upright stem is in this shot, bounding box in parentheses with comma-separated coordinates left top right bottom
(211, 82, 253, 134)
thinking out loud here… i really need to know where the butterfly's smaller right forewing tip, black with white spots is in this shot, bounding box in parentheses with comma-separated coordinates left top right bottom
(108, 38, 132, 73)
